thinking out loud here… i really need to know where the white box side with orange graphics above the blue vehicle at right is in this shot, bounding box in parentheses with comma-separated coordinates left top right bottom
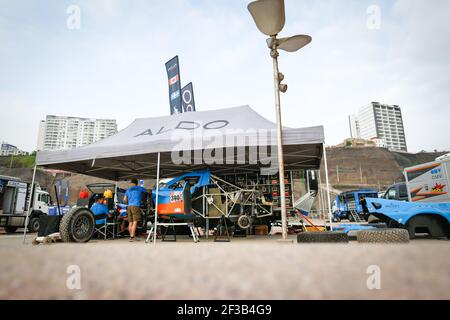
(404, 153, 450, 202)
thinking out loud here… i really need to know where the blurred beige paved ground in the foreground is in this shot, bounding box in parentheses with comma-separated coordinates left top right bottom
(0, 234, 450, 299)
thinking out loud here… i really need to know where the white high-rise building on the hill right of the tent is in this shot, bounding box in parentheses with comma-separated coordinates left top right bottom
(349, 102, 408, 152)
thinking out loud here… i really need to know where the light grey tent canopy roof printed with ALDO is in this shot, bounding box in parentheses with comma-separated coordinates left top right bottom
(36, 106, 324, 181)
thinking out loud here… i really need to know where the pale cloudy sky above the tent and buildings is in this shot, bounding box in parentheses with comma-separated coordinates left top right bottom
(0, 0, 450, 152)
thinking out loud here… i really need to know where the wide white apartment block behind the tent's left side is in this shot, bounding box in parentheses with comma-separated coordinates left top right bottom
(37, 115, 117, 150)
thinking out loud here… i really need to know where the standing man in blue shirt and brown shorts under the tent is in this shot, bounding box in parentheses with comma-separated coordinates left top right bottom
(124, 179, 147, 242)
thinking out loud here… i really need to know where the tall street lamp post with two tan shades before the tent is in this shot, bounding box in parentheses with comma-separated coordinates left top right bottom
(248, 0, 312, 240)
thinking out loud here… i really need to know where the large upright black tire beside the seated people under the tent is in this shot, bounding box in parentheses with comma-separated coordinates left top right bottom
(59, 207, 95, 242)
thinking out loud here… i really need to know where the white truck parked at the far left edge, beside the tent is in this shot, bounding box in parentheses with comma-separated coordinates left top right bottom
(0, 175, 51, 233)
